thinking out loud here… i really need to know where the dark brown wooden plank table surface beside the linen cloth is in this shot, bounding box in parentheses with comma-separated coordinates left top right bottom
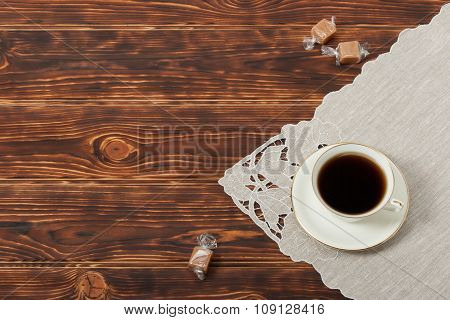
(0, 0, 445, 299)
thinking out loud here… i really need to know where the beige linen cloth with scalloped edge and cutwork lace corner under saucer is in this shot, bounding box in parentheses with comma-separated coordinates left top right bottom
(219, 4, 450, 299)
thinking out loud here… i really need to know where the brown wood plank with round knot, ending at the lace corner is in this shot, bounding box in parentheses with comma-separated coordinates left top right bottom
(0, 100, 312, 183)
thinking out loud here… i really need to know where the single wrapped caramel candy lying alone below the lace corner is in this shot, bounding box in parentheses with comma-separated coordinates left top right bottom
(188, 233, 217, 280)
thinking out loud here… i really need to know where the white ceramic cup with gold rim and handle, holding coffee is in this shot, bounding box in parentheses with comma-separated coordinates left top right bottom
(312, 143, 404, 221)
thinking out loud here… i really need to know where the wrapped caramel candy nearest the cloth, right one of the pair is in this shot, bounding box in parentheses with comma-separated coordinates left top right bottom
(322, 41, 369, 66)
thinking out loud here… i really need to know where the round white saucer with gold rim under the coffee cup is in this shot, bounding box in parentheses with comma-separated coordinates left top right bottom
(292, 146, 409, 250)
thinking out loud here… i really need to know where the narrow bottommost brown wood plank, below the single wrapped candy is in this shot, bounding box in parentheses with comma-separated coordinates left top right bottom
(0, 263, 344, 299)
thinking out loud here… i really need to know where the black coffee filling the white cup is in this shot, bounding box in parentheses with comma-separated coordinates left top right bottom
(317, 153, 387, 215)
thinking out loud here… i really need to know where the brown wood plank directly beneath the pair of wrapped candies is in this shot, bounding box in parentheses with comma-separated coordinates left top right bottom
(0, 25, 411, 100)
